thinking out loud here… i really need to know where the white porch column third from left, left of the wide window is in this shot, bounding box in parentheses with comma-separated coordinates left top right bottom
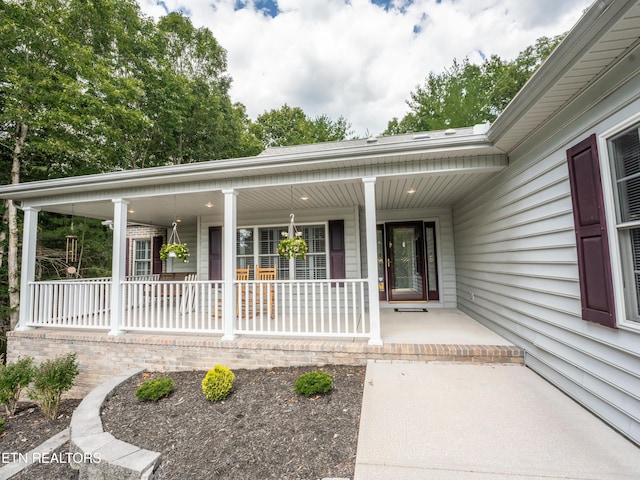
(222, 189, 238, 340)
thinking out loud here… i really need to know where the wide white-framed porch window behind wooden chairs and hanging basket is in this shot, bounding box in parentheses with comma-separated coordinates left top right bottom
(237, 225, 328, 280)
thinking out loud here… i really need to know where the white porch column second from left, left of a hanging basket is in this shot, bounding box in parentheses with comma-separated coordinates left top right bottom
(109, 198, 129, 335)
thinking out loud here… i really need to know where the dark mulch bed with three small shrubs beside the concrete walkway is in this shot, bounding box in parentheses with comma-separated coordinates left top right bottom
(102, 366, 365, 480)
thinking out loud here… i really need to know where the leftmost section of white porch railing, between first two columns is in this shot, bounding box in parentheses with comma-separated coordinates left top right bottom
(29, 278, 111, 328)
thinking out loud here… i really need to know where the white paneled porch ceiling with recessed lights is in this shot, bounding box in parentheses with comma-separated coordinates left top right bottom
(43, 172, 495, 226)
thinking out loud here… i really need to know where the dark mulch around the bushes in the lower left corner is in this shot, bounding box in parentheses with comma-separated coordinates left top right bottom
(0, 399, 80, 480)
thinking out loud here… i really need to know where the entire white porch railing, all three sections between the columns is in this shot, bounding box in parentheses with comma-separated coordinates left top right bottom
(28, 278, 370, 338)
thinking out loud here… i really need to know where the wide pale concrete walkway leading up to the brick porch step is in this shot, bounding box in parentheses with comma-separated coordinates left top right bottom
(355, 361, 640, 480)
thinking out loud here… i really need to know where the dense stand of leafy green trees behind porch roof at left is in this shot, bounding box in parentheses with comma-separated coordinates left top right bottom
(0, 0, 262, 338)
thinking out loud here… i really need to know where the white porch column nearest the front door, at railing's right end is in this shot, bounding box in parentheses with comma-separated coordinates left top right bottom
(362, 177, 382, 345)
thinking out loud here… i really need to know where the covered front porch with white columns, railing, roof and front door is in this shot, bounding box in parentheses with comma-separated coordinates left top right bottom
(6, 126, 508, 346)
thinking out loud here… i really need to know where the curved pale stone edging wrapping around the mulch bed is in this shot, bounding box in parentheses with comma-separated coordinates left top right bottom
(69, 368, 161, 480)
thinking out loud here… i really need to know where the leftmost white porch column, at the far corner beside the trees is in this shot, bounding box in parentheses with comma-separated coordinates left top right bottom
(16, 207, 40, 330)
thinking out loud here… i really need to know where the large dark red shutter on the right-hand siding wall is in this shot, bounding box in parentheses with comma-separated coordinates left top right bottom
(567, 135, 616, 328)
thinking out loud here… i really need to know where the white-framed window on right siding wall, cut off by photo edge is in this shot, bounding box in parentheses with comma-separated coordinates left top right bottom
(609, 124, 640, 322)
